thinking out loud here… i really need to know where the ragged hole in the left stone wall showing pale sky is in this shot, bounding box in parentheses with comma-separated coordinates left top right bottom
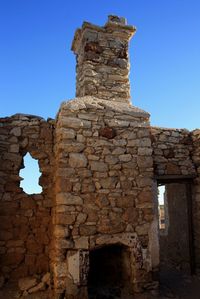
(19, 153, 42, 194)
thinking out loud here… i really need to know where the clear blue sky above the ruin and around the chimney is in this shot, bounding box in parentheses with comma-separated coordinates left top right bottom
(0, 0, 200, 129)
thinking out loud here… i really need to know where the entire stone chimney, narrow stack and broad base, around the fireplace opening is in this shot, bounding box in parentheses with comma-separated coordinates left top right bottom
(52, 17, 157, 298)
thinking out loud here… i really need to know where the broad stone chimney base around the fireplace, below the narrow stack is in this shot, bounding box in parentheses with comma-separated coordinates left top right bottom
(52, 97, 156, 298)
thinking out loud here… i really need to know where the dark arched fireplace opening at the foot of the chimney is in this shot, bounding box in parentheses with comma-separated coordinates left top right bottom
(88, 245, 131, 299)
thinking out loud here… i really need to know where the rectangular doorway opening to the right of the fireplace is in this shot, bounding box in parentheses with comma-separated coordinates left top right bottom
(158, 180, 194, 274)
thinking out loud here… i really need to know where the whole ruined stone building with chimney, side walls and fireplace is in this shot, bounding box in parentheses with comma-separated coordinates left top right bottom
(0, 16, 200, 299)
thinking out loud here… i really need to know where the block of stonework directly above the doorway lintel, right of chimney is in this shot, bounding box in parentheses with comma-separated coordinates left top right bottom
(150, 127, 196, 176)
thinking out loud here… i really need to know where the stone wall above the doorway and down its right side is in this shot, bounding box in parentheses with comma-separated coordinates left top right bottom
(150, 127, 200, 273)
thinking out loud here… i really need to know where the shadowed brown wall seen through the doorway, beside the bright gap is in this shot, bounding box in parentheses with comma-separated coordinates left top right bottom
(160, 183, 192, 274)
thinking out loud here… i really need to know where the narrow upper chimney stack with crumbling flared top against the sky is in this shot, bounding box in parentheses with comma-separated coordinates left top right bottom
(72, 16, 136, 103)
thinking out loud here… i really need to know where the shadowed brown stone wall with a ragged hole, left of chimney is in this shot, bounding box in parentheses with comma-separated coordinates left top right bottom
(0, 114, 54, 279)
